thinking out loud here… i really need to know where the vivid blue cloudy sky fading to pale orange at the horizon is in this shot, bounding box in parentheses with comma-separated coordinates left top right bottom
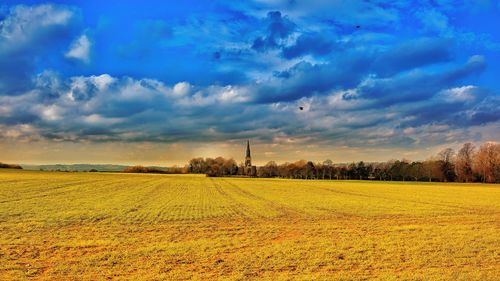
(0, 0, 500, 165)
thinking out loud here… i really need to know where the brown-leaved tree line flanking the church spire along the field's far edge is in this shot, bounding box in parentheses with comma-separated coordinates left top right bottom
(185, 142, 500, 183)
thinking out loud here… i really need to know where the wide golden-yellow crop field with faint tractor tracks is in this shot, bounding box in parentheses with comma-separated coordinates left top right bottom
(0, 167, 500, 280)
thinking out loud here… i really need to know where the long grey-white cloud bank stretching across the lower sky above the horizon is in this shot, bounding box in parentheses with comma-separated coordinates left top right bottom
(0, 64, 500, 150)
